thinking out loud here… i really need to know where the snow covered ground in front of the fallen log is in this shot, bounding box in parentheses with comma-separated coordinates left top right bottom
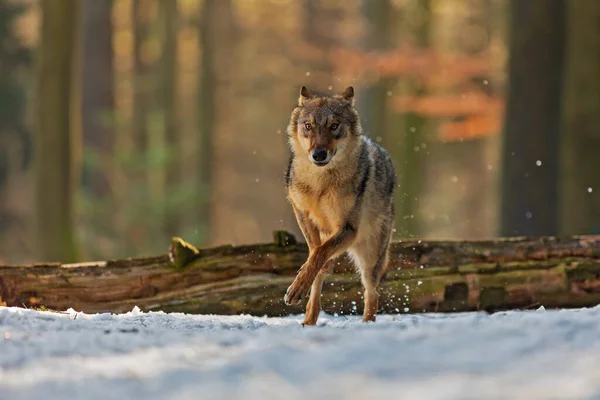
(0, 307, 600, 400)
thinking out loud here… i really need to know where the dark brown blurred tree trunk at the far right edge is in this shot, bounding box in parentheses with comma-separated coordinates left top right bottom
(561, 0, 600, 234)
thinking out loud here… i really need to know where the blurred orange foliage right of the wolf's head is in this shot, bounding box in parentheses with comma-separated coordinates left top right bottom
(328, 48, 504, 141)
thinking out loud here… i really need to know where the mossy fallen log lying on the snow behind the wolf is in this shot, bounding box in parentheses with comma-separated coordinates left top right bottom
(0, 232, 600, 316)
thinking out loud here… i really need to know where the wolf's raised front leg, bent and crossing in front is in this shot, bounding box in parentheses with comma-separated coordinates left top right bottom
(284, 222, 356, 305)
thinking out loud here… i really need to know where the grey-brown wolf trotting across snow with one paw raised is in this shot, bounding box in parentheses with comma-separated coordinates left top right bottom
(284, 86, 396, 325)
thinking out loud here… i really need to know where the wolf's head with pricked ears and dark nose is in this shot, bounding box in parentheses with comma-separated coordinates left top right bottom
(287, 86, 362, 167)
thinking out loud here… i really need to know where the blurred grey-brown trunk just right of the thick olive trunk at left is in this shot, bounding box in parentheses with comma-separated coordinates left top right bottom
(76, 0, 119, 258)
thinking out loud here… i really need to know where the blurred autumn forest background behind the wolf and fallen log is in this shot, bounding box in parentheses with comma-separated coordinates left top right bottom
(0, 0, 600, 263)
